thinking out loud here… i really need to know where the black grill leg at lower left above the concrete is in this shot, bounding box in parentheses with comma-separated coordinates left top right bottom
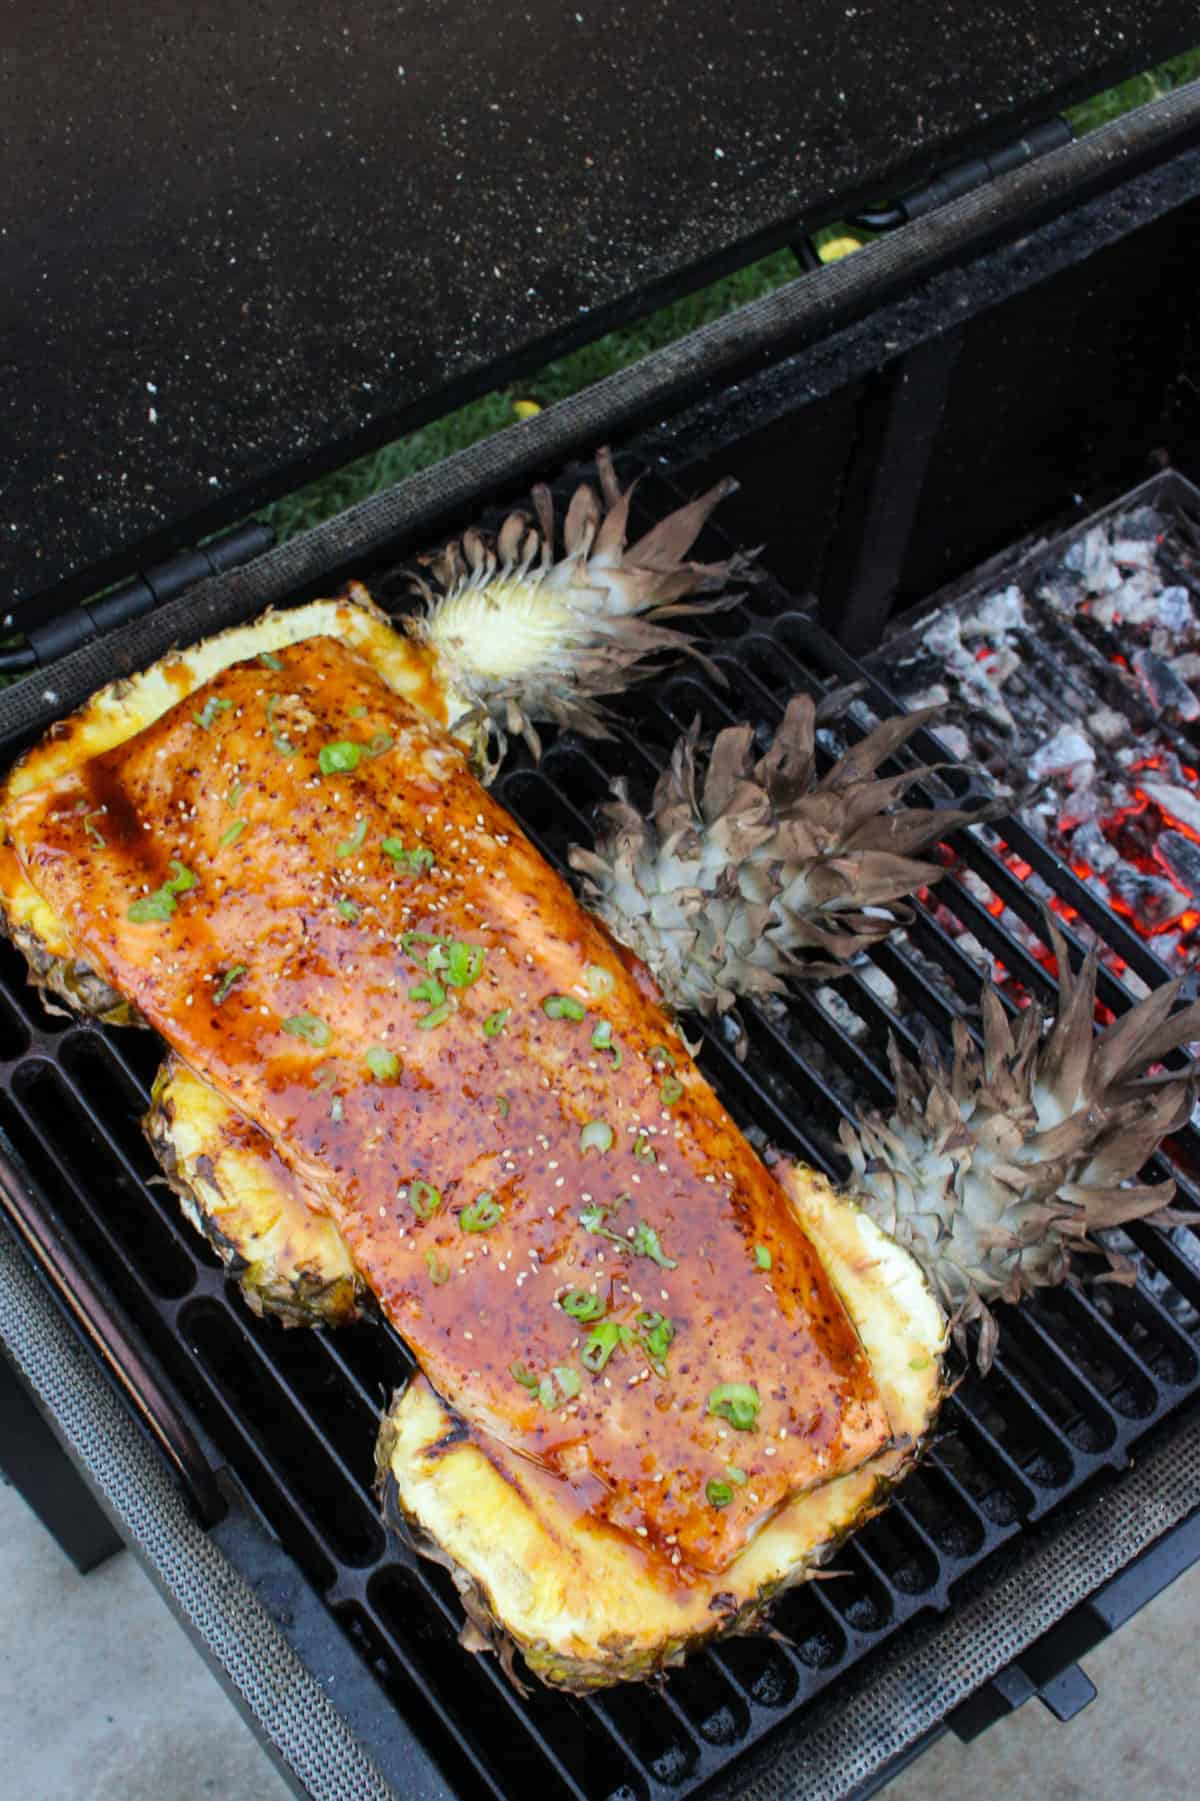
(0, 1347, 123, 1576)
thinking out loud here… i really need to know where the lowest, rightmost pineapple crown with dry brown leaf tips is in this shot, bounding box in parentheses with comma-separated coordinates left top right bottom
(841, 917, 1200, 1372)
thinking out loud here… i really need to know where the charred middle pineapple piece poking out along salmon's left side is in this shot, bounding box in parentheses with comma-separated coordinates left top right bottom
(142, 1057, 362, 1326)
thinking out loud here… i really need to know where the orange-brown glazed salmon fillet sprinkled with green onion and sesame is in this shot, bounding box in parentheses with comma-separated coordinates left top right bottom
(5, 638, 890, 1570)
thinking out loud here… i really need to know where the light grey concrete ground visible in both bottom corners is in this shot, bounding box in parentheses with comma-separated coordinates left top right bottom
(0, 1486, 1200, 1801)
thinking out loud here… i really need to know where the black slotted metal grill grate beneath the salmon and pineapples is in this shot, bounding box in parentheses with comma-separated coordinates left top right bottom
(0, 477, 1200, 1801)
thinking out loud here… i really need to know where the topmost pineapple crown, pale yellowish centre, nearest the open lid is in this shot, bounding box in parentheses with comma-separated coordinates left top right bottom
(407, 450, 753, 780)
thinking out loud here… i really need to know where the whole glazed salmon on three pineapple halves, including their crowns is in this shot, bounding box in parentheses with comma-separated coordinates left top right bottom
(0, 459, 1200, 1688)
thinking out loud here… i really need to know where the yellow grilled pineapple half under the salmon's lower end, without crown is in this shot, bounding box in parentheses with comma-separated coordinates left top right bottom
(377, 1165, 948, 1693)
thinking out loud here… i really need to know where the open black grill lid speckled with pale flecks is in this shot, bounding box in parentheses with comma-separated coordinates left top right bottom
(0, 0, 1196, 619)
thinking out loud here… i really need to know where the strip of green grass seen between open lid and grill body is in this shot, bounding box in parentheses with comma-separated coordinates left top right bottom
(259, 50, 1200, 542)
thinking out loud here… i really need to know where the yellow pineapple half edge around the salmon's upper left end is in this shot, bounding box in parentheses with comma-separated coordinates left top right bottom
(0, 582, 439, 1025)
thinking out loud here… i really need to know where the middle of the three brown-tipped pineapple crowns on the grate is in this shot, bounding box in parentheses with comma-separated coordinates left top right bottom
(571, 695, 987, 1016)
